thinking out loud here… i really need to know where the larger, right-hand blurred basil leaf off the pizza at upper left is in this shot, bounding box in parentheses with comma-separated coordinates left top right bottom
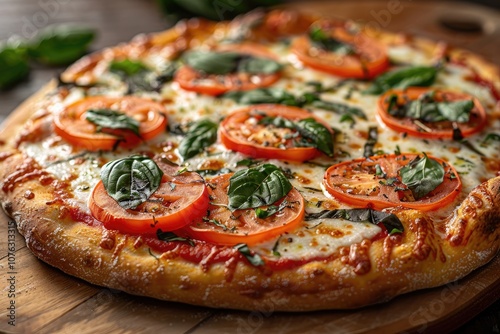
(28, 24, 96, 65)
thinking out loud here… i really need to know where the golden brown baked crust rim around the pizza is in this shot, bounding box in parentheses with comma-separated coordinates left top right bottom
(0, 7, 500, 311)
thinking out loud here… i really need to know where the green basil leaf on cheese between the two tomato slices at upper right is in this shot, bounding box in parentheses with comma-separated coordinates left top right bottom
(365, 66, 438, 94)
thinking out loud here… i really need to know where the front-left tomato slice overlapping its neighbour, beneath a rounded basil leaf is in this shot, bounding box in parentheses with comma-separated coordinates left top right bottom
(89, 162, 209, 235)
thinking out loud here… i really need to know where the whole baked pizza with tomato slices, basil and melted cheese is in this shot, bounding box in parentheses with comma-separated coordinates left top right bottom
(0, 9, 500, 311)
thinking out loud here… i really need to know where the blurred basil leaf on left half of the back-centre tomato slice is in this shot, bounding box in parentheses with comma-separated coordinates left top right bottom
(183, 51, 241, 75)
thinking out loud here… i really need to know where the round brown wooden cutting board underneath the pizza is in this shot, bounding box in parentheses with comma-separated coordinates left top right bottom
(0, 1, 500, 333)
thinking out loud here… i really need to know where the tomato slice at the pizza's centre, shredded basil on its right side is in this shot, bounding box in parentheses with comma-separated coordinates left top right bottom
(219, 104, 333, 161)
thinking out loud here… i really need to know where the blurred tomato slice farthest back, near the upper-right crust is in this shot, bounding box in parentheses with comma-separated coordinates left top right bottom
(291, 22, 389, 79)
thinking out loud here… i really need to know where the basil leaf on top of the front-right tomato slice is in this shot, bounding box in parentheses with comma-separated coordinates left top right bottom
(399, 153, 444, 199)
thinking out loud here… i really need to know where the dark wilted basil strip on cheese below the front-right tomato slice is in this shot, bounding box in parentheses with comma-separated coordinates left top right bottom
(305, 209, 404, 234)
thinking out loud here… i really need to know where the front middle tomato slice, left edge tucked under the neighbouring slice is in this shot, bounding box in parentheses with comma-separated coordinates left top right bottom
(183, 173, 305, 245)
